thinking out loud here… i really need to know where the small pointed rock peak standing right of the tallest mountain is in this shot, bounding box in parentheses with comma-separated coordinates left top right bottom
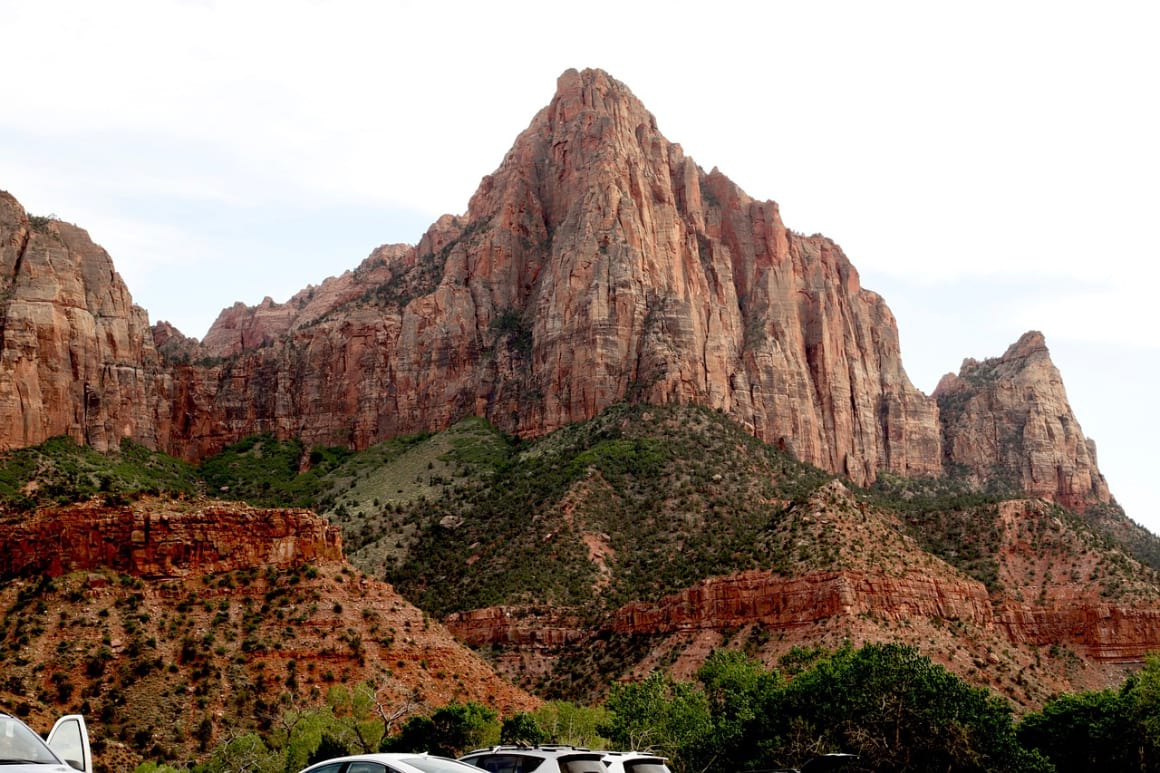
(934, 331, 1111, 511)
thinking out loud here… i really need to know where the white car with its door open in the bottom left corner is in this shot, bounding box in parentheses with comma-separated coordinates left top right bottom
(0, 713, 93, 773)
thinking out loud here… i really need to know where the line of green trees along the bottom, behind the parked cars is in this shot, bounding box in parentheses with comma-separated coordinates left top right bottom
(137, 644, 1160, 773)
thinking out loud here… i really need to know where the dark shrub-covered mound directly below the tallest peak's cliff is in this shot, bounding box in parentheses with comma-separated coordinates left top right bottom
(380, 405, 829, 614)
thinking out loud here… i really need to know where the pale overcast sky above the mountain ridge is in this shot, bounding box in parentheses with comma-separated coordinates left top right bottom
(0, 0, 1160, 532)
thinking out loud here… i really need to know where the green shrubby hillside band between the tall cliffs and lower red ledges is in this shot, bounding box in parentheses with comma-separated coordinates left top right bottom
(0, 405, 1160, 615)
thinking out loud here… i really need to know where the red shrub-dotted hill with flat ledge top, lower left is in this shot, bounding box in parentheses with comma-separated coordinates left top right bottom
(0, 499, 539, 773)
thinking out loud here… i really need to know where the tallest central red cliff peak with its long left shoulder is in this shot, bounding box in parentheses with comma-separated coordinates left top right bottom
(177, 71, 941, 483)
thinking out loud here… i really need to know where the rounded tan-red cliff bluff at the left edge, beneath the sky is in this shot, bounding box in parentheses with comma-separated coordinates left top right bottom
(0, 192, 172, 450)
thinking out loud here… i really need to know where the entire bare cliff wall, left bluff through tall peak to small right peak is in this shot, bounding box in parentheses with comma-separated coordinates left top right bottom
(0, 70, 1108, 506)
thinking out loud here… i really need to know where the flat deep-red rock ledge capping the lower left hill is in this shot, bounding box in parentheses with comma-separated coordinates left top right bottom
(0, 503, 342, 579)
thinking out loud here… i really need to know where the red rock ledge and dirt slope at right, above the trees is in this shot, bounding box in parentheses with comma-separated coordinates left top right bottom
(445, 481, 1160, 709)
